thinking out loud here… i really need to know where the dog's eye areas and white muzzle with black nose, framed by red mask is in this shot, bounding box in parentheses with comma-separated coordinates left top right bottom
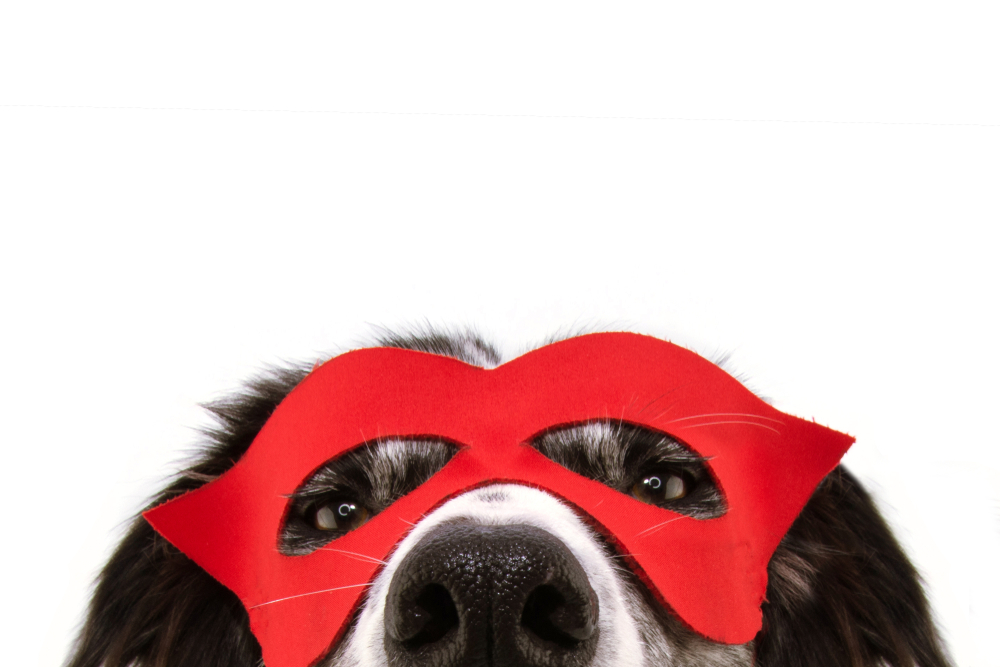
(280, 422, 752, 667)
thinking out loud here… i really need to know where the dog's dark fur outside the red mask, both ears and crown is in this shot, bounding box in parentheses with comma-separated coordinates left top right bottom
(67, 338, 949, 667)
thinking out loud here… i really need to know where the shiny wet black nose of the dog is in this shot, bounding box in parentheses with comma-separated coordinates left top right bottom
(384, 523, 599, 667)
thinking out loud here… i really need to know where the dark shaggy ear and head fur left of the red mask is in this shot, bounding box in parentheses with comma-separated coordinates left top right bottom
(66, 368, 307, 667)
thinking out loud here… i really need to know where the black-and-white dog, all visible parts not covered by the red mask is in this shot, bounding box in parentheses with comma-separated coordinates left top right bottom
(67, 332, 950, 667)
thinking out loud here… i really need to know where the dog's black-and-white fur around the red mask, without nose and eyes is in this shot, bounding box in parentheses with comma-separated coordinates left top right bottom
(67, 333, 949, 667)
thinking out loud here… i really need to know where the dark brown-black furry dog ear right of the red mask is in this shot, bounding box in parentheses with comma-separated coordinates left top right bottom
(756, 467, 950, 667)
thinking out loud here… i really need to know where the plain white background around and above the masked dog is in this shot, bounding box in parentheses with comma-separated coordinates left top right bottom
(0, 0, 1000, 667)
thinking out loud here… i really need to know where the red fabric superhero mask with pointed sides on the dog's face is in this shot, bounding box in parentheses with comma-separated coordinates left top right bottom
(145, 333, 853, 667)
